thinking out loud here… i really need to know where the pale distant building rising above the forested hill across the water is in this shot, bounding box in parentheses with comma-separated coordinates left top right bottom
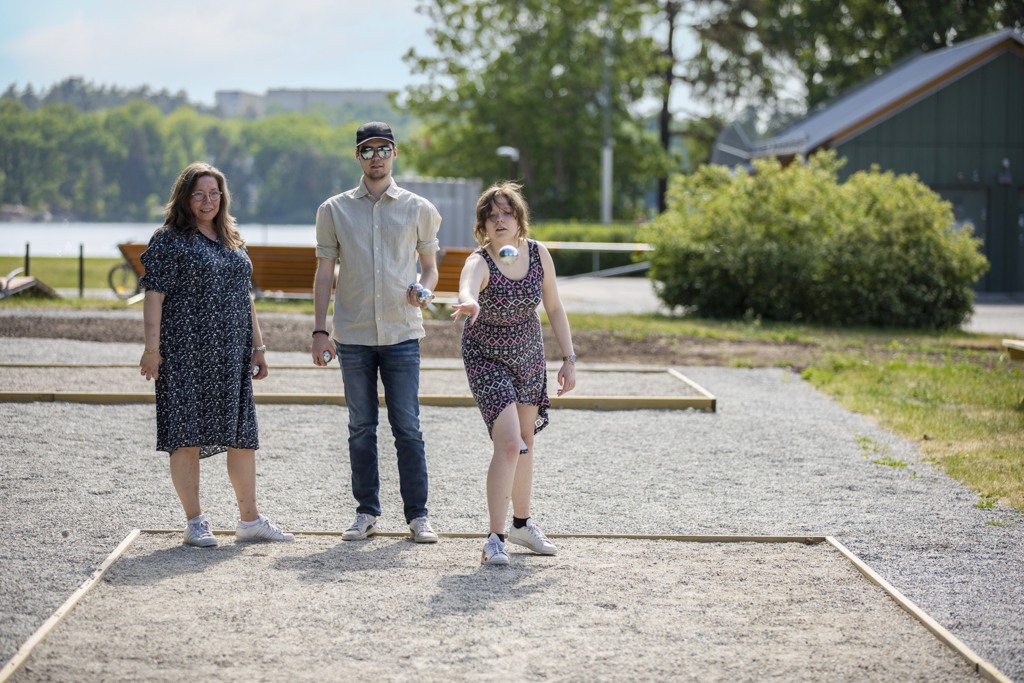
(215, 88, 390, 119)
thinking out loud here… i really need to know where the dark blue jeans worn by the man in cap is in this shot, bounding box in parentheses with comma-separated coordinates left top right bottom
(335, 339, 427, 522)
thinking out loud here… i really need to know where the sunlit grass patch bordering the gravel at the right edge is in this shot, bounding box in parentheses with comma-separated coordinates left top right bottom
(803, 339, 1024, 516)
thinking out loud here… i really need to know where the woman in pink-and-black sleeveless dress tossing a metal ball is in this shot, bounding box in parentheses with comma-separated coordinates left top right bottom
(452, 182, 575, 564)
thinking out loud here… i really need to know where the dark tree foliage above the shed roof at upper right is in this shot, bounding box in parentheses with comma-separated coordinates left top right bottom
(679, 0, 1024, 113)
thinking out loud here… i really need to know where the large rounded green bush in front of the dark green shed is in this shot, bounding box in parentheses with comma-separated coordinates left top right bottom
(640, 152, 988, 330)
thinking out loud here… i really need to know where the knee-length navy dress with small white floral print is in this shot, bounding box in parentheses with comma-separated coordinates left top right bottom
(140, 228, 259, 458)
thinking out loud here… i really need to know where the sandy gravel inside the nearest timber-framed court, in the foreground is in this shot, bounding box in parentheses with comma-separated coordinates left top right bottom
(8, 535, 980, 683)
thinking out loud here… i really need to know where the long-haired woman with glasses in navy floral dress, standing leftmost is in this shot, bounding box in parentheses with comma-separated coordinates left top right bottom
(139, 163, 294, 547)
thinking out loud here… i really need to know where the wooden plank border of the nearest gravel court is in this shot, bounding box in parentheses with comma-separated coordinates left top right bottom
(0, 529, 1013, 683)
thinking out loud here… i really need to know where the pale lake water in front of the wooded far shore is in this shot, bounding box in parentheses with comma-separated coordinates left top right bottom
(0, 223, 316, 258)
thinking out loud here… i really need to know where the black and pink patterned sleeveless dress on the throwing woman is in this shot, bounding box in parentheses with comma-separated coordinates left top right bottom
(462, 240, 551, 434)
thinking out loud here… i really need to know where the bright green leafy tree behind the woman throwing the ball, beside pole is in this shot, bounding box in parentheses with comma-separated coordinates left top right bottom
(406, 0, 667, 218)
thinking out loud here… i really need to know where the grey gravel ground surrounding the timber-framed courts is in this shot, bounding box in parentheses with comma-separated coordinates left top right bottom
(0, 339, 1024, 680)
